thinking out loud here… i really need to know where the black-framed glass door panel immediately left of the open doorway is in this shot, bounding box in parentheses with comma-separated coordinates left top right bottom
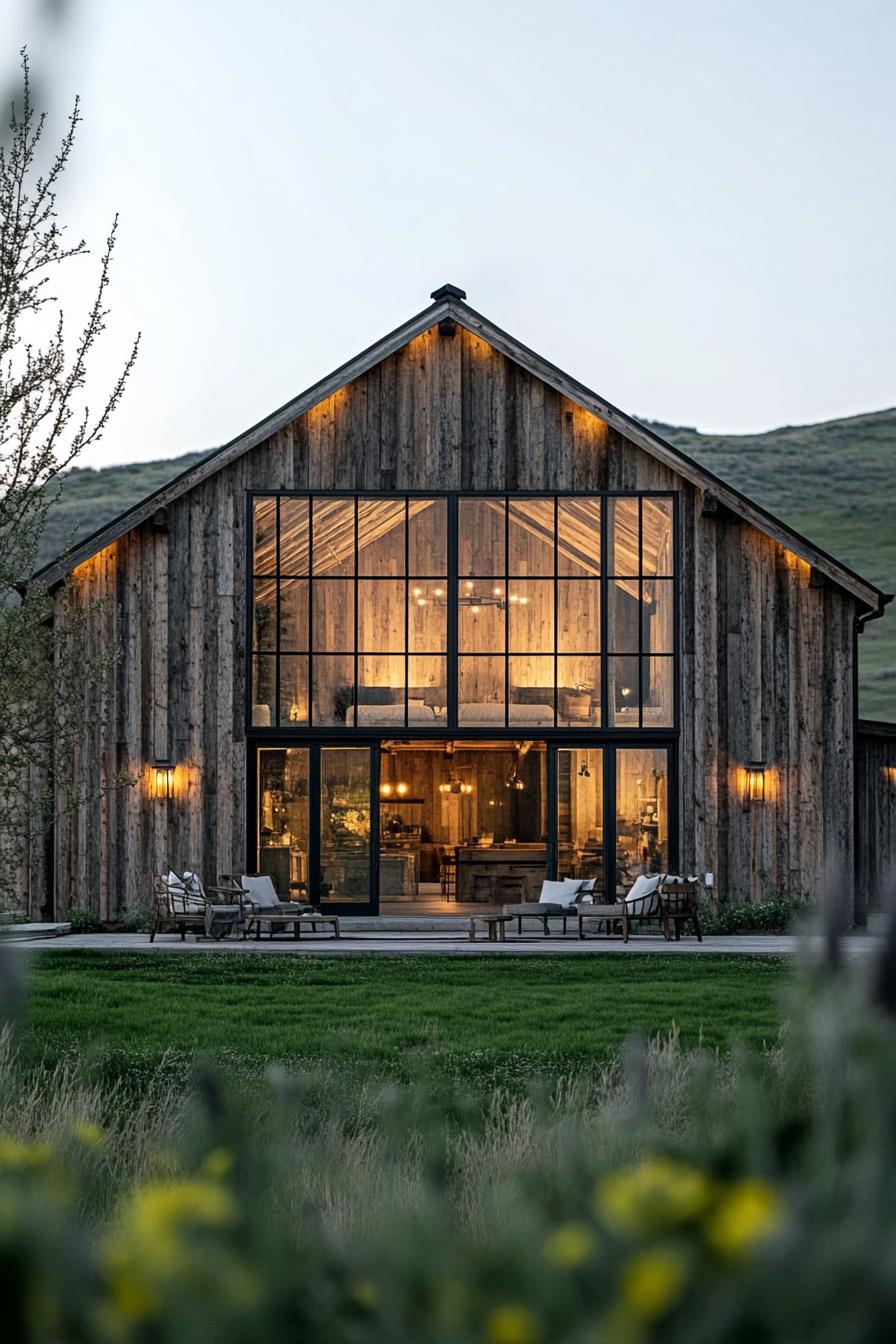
(317, 747, 372, 906)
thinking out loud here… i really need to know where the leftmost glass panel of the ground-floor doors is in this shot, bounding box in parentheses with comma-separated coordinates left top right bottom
(258, 747, 309, 900)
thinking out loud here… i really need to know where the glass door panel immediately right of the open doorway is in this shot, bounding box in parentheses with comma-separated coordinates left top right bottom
(557, 747, 606, 905)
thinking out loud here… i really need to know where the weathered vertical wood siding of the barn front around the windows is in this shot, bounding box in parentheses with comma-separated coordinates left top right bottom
(43, 327, 854, 915)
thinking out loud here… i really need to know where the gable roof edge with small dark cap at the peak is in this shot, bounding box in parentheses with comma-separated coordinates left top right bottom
(34, 285, 892, 614)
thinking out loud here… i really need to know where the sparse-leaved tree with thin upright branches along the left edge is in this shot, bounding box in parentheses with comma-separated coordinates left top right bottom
(0, 51, 140, 913)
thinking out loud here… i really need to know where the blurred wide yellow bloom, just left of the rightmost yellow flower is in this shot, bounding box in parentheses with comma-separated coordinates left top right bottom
(595, 1157, 712, 1234)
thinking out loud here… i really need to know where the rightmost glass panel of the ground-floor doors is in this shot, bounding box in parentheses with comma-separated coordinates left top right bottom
(615, 747, 669, 894)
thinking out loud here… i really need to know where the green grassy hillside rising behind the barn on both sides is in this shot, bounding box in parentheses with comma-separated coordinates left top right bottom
(44, 409, 896, 720)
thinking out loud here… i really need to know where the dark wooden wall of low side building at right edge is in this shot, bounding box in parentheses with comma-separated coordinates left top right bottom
(856, 720, 896, 922)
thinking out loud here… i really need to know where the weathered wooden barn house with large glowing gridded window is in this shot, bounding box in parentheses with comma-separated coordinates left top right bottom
(31, 285, 888, 918)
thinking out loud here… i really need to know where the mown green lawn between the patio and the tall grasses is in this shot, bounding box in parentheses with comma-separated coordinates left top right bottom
(23, 952, 790, 1082)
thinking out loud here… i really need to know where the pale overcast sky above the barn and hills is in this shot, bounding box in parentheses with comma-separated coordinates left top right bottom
(0, 0, 896, 465)
